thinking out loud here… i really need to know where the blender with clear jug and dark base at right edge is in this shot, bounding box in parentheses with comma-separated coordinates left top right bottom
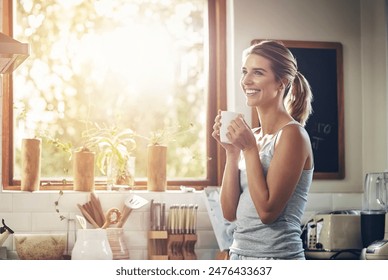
(361, 172, 388, 248)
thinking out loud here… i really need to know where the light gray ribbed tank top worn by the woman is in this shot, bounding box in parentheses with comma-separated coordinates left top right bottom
(230, 121, 313, 259)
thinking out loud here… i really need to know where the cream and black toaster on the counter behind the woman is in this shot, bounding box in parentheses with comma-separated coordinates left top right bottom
(304, 210, 363, 259)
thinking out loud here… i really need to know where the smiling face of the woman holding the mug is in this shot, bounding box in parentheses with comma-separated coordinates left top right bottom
(240, 54, 281, 107)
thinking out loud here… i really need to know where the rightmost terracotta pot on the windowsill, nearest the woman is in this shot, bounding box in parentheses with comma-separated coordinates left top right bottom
(147, 145, 167, 192)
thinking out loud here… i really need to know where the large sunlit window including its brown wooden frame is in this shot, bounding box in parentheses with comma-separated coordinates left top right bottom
(2, 0, 226, 189)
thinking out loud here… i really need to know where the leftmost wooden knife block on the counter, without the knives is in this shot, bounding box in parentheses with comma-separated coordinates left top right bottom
(148, 230, 168, 260)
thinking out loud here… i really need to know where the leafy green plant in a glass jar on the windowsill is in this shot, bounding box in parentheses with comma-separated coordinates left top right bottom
(83, 124, 136, 189)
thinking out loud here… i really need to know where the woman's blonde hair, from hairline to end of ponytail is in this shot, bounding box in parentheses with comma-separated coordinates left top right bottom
(244, 40, 313, 126)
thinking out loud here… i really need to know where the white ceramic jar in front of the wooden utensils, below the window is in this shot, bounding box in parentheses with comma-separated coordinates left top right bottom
(71, 228, 113, 260)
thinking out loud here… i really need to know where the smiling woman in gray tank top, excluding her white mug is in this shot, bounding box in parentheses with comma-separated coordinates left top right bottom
(212, 41, 314, 260)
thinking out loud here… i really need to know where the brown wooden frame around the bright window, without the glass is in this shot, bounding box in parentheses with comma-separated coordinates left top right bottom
(2, 0, 226, 190)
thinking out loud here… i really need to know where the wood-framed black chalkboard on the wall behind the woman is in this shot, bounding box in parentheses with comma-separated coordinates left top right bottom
(252, 40, 345, 179)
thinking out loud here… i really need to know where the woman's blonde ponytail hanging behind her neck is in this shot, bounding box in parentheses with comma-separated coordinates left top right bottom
(284, 71, 313, 126)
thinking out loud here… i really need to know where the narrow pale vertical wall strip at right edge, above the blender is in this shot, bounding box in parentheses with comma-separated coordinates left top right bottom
(361, 0, 388, 175)
